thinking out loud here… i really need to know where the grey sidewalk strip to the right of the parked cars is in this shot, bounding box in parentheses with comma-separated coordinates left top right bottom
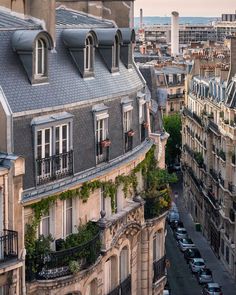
(172, 183, 236, 295)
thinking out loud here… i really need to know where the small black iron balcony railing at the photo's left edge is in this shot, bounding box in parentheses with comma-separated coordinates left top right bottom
(0, 229, 18, 263)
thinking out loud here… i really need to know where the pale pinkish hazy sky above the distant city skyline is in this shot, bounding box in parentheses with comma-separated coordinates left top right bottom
(134, 0, 236, 16)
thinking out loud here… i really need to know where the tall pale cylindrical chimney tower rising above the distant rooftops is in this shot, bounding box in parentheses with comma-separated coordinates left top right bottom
(171, 11, 179, 56)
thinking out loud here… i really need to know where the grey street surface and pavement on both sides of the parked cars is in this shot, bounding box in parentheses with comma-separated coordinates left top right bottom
(166, 176, 236, 295)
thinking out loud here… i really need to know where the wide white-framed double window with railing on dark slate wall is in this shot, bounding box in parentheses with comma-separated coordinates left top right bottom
(31, 112, 73, 184)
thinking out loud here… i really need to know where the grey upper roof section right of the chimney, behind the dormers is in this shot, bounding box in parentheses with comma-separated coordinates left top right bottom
(56, 7, 115, 28)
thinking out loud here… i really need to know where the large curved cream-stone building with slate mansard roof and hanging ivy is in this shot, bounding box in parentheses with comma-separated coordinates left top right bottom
(0, 1, 168, 295)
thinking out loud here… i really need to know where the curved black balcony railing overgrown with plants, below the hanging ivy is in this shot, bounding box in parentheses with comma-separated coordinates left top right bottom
(26, 233, 101, 281)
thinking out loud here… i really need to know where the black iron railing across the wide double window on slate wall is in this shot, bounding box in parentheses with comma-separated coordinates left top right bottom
(36, 151, 73, 184)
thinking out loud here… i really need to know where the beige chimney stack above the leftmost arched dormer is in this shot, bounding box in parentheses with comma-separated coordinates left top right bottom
(25, 0, 56, 44)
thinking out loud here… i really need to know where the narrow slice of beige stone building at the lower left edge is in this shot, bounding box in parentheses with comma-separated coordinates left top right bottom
(0, 154, 25, 295)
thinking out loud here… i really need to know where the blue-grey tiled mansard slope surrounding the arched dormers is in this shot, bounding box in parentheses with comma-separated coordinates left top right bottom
(0, 29, 143, 113)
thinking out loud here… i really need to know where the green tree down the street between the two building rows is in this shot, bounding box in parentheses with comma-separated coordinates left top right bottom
(163, 113, 182, 165)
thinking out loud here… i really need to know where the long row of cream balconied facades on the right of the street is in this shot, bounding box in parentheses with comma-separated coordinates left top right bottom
(182, 38, 236, 278)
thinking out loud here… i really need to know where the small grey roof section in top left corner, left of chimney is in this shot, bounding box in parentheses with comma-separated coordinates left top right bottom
(0, 10, 40, 30)
